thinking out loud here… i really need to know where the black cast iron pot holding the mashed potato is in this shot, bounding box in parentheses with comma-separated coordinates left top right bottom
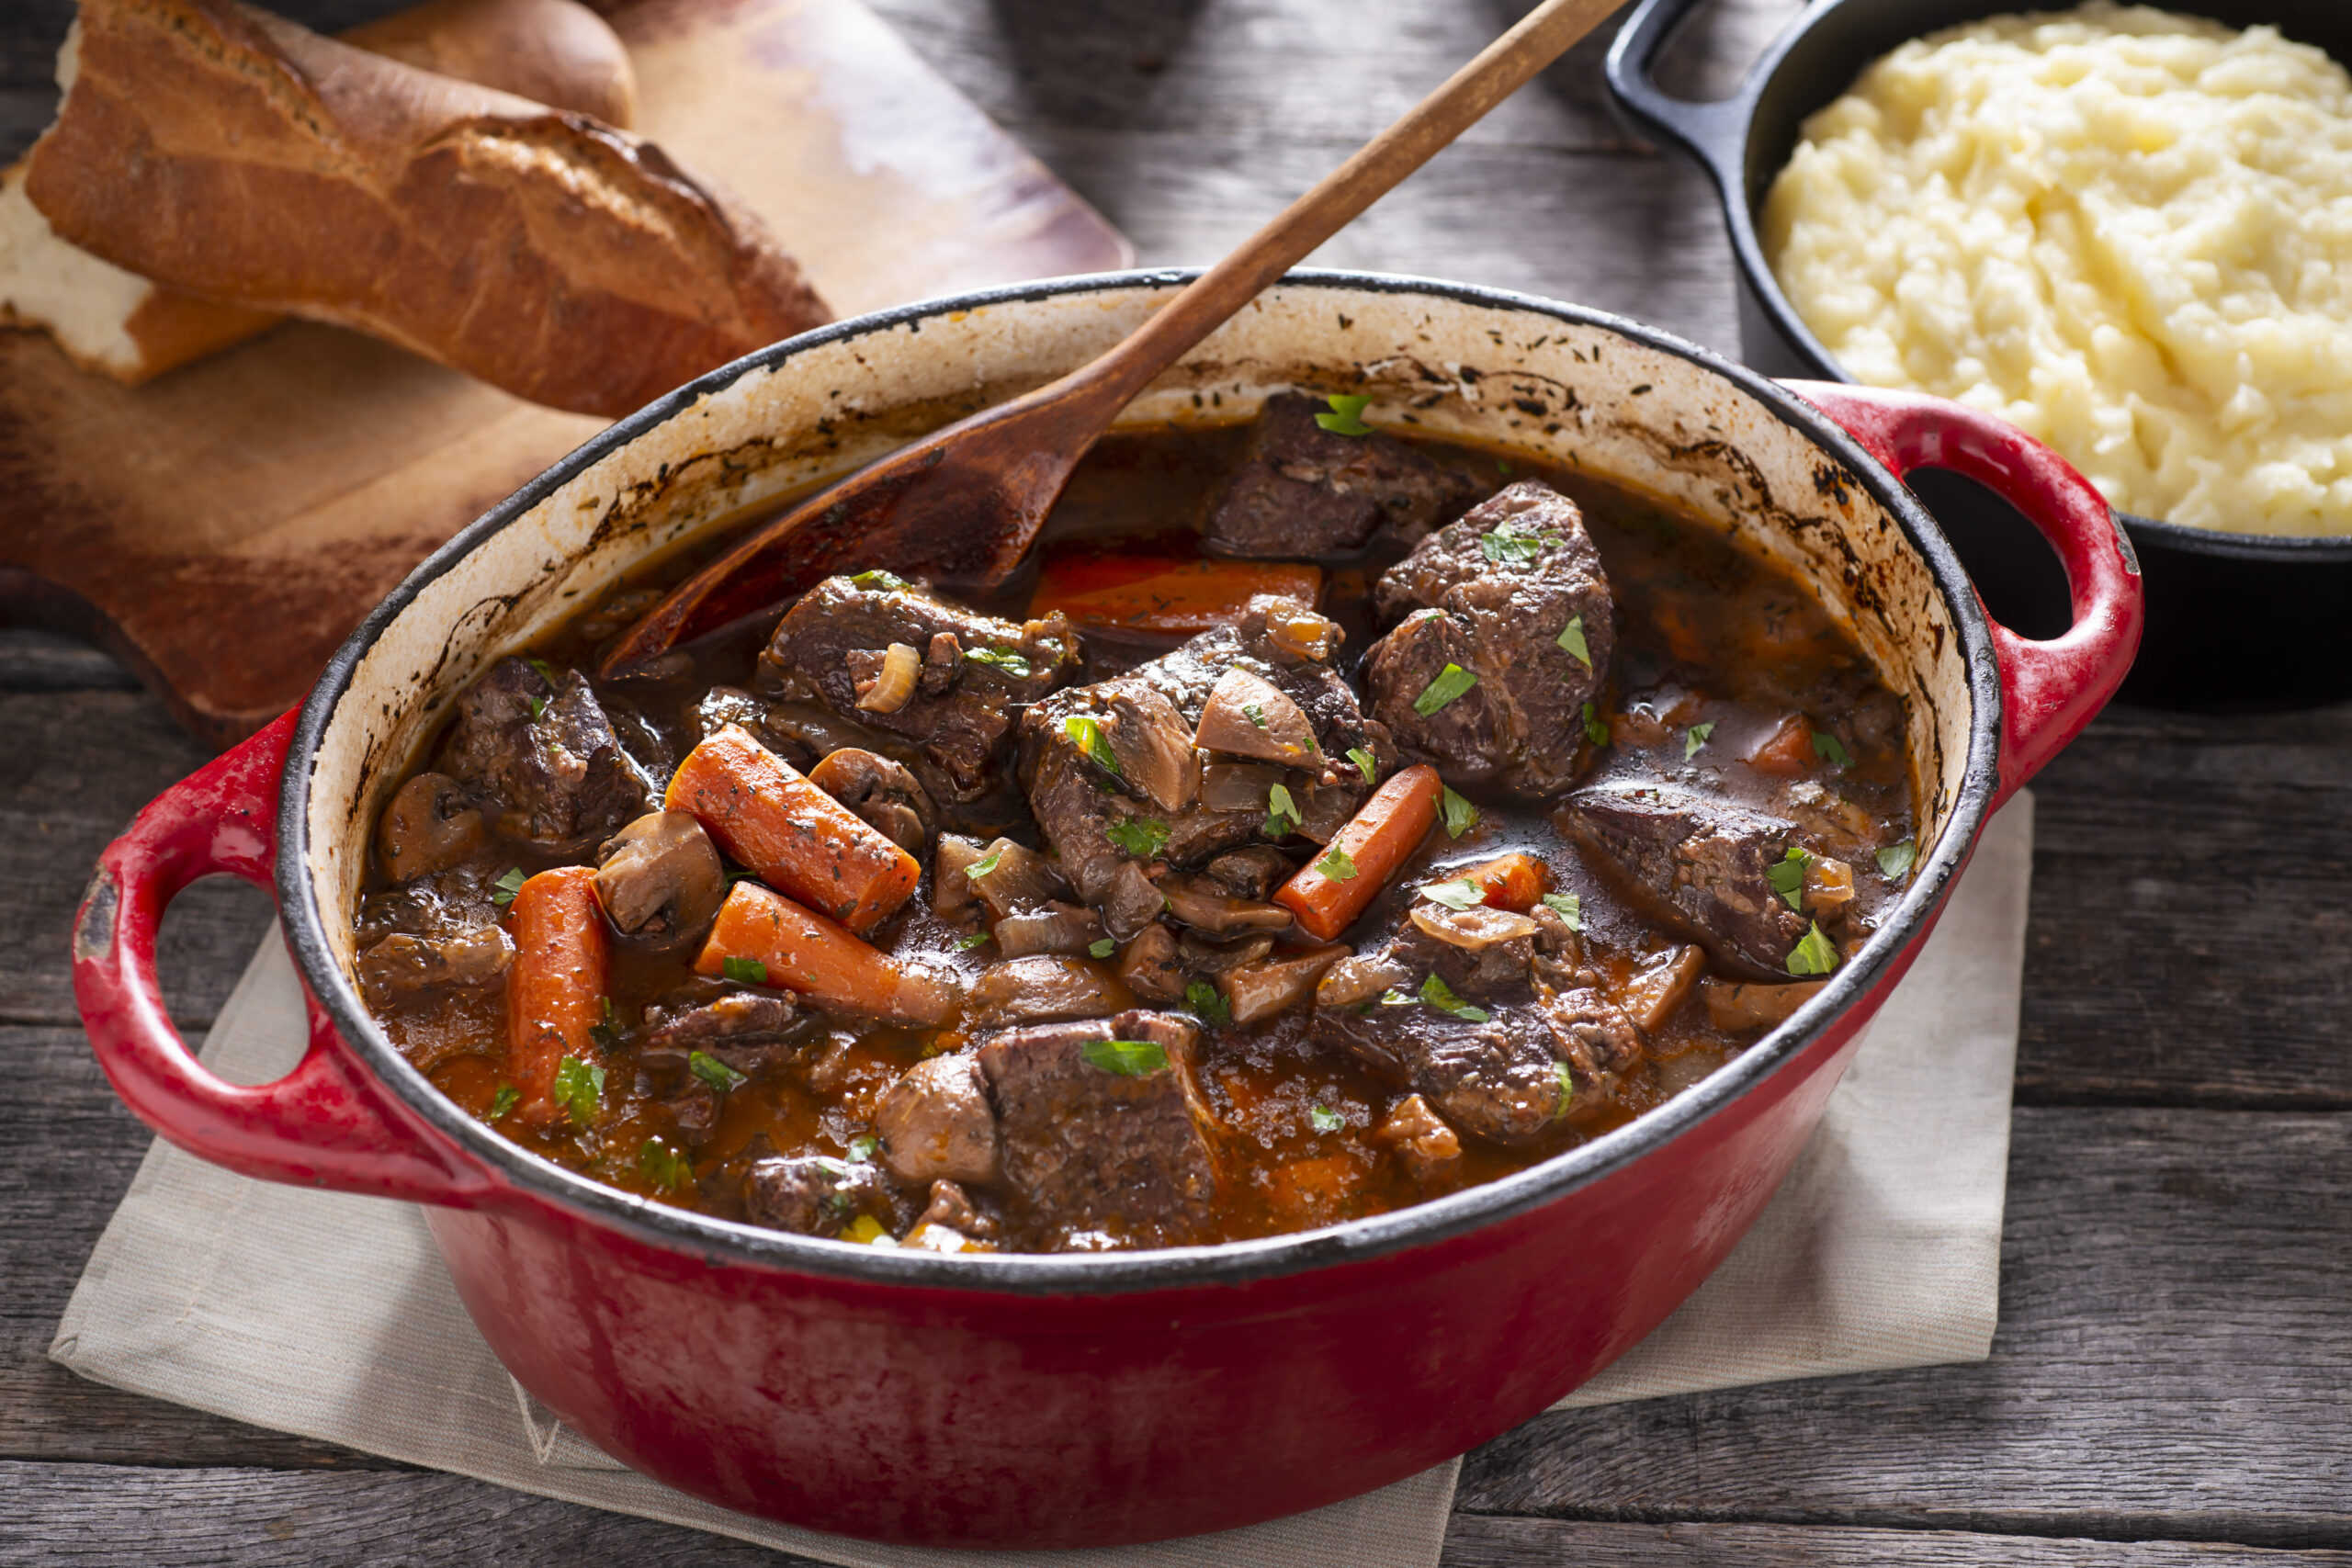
(1609, 0, 2352, 710)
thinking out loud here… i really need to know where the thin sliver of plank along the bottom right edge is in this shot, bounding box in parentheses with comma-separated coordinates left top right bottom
(1442, 1514, 2352, 1568)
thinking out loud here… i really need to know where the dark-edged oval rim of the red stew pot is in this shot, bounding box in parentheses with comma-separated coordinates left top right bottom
(277, 270, 2002, 1295)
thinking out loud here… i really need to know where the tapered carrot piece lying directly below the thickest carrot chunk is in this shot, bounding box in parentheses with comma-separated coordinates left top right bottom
(694, 882, 955, 1025)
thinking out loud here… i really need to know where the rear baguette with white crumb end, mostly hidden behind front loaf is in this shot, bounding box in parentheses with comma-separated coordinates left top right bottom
(0, 0, 638, 386)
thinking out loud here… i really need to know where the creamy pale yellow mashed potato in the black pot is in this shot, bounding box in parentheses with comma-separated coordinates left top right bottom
(1764, 0, 2352, 534)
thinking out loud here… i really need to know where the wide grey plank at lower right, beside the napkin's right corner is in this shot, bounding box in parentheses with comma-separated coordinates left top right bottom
(1456, 1107, 2352, 1550)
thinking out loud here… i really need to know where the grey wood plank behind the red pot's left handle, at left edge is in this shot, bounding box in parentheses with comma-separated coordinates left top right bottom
(0, 691, 270, 1027)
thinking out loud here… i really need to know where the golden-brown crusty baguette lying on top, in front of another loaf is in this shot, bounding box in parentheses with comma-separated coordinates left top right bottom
(26, 0, 828, 416)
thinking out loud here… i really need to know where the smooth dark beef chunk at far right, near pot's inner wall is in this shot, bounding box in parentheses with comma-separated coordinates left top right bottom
(1559, 783, 1809, 980)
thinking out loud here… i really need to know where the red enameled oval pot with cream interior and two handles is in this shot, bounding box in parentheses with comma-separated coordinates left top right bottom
(75, 273, 2141, 1547)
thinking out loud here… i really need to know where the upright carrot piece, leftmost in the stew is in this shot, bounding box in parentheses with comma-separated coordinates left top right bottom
(505, 865, 609, 1128)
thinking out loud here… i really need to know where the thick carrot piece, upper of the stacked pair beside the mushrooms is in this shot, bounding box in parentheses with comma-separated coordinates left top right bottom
(663, 724, 922, 936)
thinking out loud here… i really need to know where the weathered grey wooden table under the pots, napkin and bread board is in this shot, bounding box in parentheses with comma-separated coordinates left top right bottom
(0, 0, 2352, 1568)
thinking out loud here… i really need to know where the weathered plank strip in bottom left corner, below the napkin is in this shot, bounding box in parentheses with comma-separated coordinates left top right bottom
(0, 1464, 837, 1568)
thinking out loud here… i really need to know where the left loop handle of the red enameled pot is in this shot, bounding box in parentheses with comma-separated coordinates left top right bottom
(73, 712, 489, 1206)
